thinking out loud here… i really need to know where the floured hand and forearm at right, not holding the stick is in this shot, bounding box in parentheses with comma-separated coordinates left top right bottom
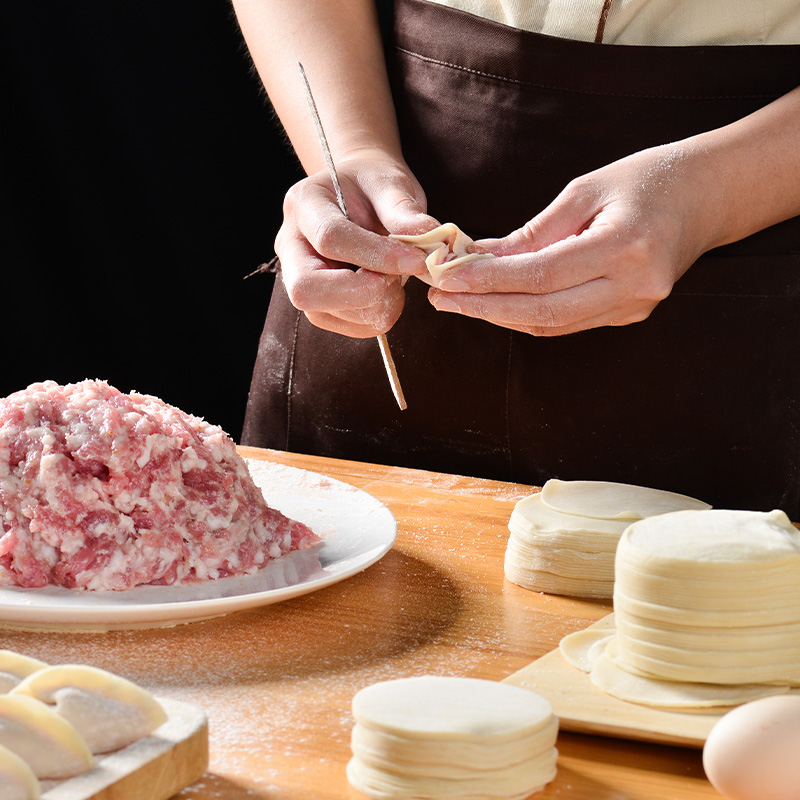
(429, 90, 800, 336)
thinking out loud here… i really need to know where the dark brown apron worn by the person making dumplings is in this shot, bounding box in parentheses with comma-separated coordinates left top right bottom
(243, 0, 800, 519)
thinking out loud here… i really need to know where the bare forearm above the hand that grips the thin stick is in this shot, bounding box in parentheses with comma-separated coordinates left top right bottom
(228, 0, 402, 174)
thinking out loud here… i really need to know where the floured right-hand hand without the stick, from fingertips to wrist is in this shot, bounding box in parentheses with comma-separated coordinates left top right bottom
(429, 143, 724, 336)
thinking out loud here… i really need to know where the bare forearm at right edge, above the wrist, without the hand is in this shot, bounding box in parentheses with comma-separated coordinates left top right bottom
(686, 88, 800, 247)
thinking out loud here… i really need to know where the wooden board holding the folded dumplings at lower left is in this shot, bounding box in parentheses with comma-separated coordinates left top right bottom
(40, 698, 208, 800)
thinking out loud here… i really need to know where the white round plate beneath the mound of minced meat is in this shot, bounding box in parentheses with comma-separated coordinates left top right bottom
(0, 459, 397, 630)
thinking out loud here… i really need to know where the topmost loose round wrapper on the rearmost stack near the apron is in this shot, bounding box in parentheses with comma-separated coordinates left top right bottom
(542, 479, 711, 520)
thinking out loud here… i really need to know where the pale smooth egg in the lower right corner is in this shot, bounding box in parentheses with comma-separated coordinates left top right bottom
(703, 695, 800, 800)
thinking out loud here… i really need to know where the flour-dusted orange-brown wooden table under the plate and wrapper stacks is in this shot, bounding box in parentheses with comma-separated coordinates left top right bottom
(0, 448, 719, 800)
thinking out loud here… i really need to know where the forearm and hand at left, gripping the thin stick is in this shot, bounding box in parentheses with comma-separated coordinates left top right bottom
(228, 0, 438, 337)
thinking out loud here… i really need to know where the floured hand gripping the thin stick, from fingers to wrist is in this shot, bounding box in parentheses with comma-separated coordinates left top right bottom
(275, 152, 438, 338)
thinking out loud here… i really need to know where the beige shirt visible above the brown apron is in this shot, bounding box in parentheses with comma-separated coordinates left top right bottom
(430, 0, 800, 46)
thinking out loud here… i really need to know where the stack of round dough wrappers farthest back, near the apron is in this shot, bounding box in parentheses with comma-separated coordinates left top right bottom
(505, 479, 709, 599)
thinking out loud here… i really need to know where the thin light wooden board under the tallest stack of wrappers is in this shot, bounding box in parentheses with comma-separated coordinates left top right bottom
(505, 618, 728, 748)
